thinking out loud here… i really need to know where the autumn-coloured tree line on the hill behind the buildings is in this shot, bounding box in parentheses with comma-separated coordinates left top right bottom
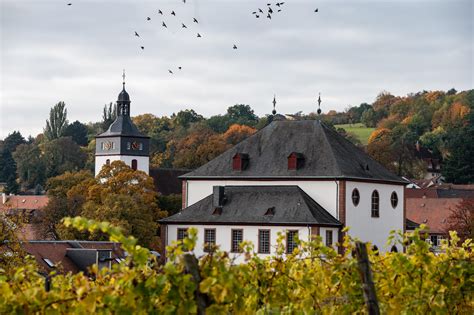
(0, 89, 474, 198)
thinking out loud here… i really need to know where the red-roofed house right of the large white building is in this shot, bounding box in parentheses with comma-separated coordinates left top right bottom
(405, 184, 474, 250)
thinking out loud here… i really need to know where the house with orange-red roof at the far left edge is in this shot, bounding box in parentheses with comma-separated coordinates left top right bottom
(0, 194, 49, 240)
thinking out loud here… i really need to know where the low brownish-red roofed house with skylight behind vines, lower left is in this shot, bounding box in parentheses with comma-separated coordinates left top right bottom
(23, 241, 125, 274)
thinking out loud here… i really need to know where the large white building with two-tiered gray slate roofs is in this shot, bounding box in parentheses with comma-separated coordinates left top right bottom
(160, 117, 407, 255)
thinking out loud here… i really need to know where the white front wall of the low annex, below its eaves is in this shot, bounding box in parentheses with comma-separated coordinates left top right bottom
(166, 225, 312, 263)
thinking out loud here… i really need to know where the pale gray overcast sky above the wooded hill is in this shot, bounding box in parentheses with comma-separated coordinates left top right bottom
(0, 0, 474, 139)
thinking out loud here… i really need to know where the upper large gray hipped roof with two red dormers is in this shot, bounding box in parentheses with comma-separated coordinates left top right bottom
(182, 120, 407, 184)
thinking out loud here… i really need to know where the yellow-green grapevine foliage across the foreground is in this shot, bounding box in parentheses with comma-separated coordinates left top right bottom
(0, 217, 474, 314)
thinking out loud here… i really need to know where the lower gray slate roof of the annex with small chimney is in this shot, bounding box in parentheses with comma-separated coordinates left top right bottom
(160, 186, 341, 226)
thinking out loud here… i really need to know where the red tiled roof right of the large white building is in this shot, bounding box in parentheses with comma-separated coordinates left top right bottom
(406, 199, 462, 233)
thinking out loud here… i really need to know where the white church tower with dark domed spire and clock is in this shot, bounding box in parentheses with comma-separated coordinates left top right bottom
(95, 72, 150, 176)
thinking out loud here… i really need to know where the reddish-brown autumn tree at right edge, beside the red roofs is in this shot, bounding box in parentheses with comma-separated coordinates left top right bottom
(446, 199, 474, 241)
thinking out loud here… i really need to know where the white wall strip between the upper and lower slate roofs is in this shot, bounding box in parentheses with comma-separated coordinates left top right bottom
(186, 180, 337, 218)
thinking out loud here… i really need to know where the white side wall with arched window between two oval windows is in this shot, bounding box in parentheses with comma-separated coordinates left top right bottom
(346, 181, 404, 252)
